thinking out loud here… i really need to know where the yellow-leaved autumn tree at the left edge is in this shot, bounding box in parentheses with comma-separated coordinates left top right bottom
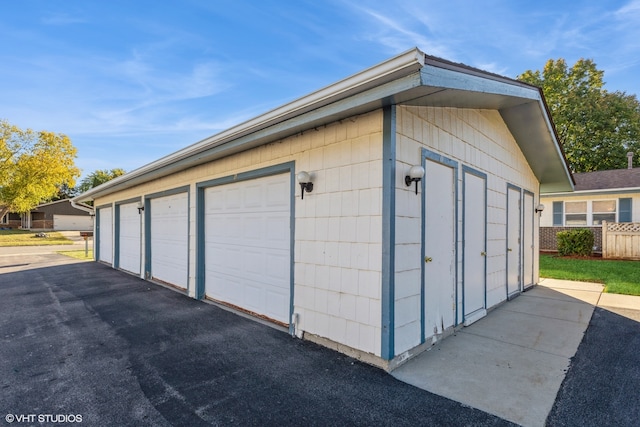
(0, 120, 80, 218)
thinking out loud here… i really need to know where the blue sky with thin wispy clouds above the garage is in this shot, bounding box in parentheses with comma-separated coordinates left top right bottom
(0, 0, 640, 181)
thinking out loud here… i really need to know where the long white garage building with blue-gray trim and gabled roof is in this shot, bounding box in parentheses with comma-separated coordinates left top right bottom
(74, 49, 573, 369)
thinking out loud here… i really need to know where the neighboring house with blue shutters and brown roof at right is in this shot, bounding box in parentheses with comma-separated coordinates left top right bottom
(540, 156, 640, 252)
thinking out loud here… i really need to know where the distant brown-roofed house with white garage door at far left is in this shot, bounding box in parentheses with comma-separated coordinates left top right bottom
(0, 199, 93, 231)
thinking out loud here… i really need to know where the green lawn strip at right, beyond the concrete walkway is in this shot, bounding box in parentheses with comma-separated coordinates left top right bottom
(540, 254, 640, 295)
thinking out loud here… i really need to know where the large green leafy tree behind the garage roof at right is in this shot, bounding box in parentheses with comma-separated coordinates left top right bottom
(518, 58, 640, 172)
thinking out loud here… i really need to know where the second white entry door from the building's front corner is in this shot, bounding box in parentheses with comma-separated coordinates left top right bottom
(462, 172, 487, 325)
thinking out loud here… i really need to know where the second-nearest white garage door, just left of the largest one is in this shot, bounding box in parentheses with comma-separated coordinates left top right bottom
(150, 193, 189, 289)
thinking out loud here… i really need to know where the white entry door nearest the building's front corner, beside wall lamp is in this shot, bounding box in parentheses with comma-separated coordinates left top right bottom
(423, 159, 456, 338)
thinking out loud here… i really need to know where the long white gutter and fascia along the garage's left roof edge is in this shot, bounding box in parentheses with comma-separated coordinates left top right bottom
(73, 48, 424, 202)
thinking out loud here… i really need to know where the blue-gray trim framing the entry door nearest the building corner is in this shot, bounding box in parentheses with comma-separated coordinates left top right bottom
(420, 148, 459, 343)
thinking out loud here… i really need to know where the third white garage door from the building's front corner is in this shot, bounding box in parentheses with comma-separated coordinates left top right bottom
(118, 202, 141, 274)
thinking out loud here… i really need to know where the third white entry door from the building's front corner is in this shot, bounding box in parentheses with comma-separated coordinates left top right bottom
(507, 187, 522, 298)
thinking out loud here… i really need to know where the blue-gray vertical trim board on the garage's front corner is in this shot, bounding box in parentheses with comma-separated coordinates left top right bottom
(380, 105, 397, 360)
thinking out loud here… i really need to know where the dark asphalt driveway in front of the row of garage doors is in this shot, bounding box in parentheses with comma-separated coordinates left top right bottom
(0, 254, 509, 426)
